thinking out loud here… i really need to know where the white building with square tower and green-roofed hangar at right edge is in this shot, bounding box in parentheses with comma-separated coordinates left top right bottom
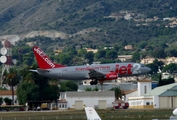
(126, 79, 177, 108)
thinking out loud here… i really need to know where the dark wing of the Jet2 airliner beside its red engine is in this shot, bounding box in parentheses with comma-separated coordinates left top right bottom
(89, 69, 105, 79)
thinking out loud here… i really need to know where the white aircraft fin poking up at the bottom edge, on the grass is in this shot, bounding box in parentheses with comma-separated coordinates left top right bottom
(85, 107, 101, 120)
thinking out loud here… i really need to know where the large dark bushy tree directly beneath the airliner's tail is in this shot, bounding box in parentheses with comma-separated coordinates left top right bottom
(17, 66, 59, 106)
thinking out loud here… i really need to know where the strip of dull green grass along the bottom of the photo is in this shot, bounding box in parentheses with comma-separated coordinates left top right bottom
(0, 109, 173, 120)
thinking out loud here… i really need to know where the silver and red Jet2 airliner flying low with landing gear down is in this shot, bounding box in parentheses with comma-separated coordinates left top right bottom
(30, 46, 151, 85)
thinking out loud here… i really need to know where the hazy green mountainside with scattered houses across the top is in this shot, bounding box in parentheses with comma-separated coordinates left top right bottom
(0, 0, 177, 46)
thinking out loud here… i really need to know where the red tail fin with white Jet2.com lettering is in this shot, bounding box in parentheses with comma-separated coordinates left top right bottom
(33, 46, 64, 69)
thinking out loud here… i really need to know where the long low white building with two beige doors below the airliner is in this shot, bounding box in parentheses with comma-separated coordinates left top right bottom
(59, 91, 115, 109)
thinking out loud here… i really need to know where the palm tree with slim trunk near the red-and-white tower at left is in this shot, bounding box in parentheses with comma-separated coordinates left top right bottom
(4, 68, 19, 105)
